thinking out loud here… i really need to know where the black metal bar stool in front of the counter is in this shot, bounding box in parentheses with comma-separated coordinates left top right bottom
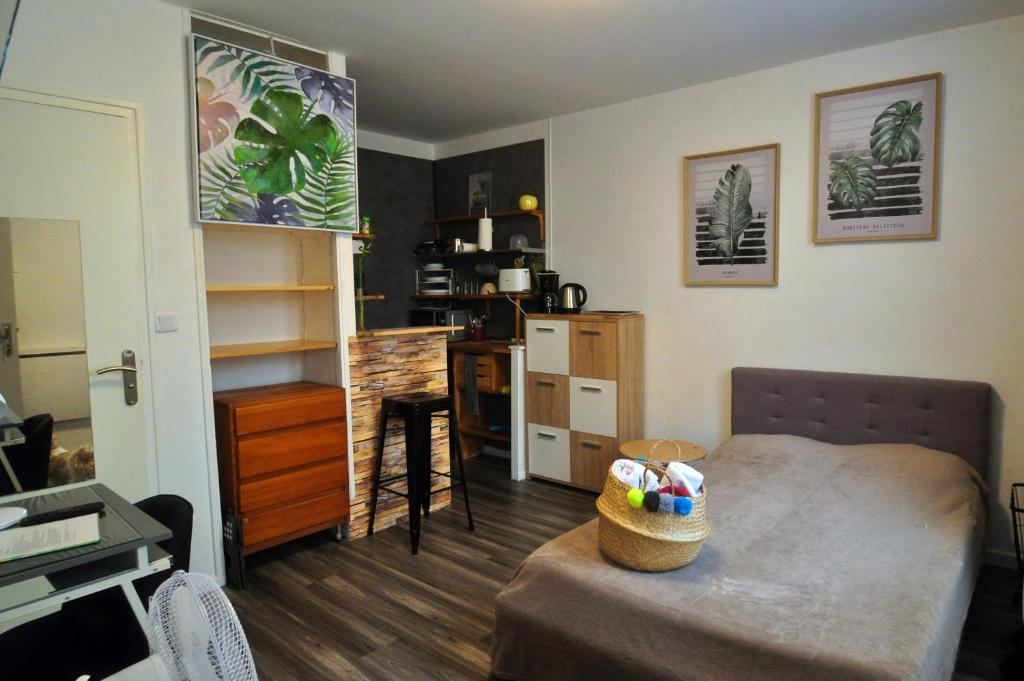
(367, 392, 474, 554)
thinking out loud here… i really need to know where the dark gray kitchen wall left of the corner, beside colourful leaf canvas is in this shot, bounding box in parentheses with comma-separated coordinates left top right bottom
(358, 148, 434, 329)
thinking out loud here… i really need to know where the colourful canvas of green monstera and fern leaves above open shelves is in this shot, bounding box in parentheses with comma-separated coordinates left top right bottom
(191, 35, 358, 231)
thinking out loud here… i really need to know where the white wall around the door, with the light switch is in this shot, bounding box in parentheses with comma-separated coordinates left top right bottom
(4, 0, 222, 573)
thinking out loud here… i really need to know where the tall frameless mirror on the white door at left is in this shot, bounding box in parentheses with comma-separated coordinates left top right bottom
(0, 218, 95, 495)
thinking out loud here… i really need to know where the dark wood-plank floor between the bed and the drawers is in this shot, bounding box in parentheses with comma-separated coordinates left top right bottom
(228, 459, 1020, 681)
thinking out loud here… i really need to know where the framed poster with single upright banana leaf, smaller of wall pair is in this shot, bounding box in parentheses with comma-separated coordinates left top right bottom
(683, 144, 779, 286)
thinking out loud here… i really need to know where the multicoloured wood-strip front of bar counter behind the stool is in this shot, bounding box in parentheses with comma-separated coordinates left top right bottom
(348, 333, 452, 539)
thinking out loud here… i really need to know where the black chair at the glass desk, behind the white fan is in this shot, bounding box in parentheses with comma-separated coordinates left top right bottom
(0, 495, 193, 681)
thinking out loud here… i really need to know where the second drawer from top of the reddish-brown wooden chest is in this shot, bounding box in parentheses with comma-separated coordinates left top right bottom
(239, 421, 348, 479)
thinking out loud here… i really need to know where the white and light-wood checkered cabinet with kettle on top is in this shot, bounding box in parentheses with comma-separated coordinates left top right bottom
(526, 312, 644, 491)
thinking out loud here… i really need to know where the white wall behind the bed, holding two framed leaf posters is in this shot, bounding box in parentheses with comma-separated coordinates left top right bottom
(550, 16, 1024, 552)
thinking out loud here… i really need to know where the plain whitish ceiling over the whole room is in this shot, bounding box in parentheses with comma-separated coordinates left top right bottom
(172, 0, 1024, 142)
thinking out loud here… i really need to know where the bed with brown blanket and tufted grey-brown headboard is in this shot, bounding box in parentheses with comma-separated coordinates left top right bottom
(492, 368, 990, 681)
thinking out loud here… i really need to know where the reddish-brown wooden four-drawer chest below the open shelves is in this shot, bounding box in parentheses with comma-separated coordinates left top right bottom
(213, 383, 348, 555)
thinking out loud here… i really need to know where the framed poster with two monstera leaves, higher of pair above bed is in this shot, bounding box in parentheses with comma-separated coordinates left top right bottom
(814, 74, 942, 244)
